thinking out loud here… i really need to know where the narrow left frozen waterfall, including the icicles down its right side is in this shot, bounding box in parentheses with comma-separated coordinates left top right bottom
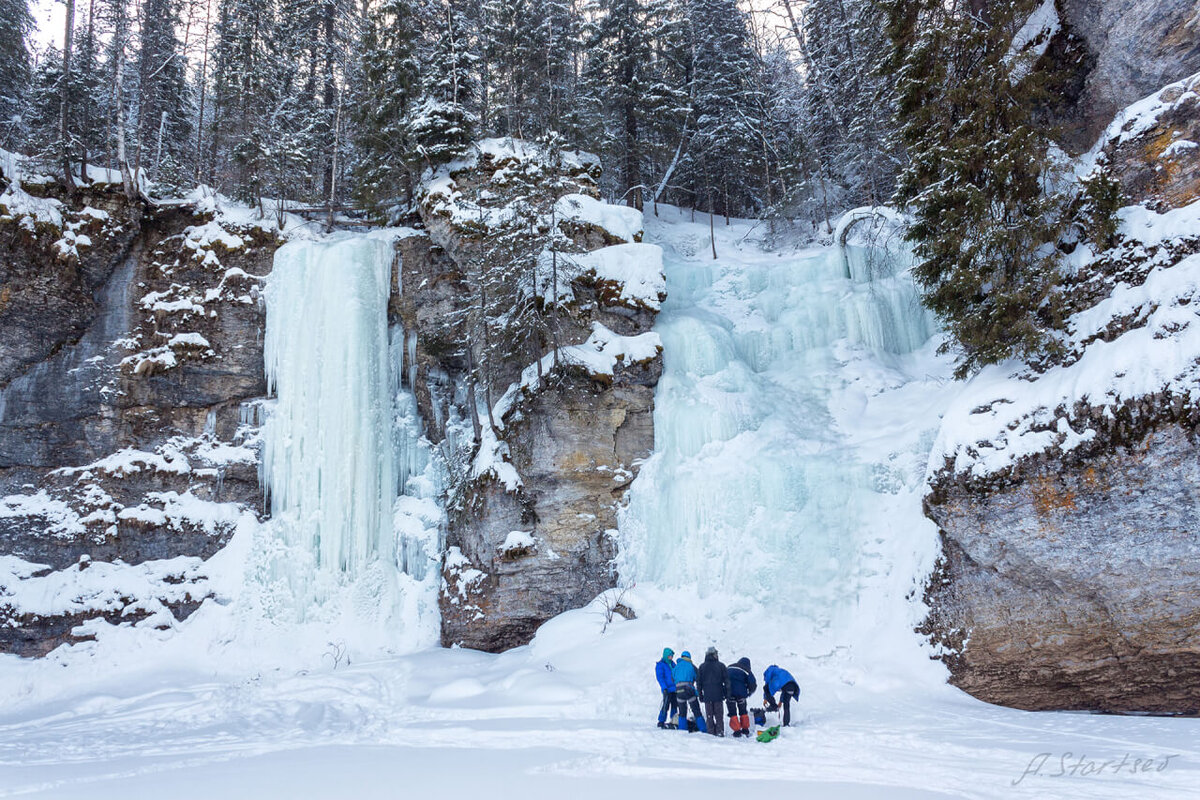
(259, 236, 440, 633)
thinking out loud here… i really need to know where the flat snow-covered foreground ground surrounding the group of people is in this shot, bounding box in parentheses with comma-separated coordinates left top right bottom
(0, 596, 1200, 800)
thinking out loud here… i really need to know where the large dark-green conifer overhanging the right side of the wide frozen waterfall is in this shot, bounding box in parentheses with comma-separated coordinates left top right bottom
(888, 0, 1067, 375)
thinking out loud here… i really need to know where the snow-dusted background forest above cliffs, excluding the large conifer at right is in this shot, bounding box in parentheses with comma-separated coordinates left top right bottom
(0, 0, 900, 218)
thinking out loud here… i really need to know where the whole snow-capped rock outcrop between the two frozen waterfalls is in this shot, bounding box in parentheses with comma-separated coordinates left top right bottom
(405, 140, 661, 651)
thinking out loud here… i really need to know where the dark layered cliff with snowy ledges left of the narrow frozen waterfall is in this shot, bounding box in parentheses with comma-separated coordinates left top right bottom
(0, 187, 276, 655)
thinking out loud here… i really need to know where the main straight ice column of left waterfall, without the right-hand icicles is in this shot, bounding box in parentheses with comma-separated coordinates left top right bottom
(263, 236, 397, 615)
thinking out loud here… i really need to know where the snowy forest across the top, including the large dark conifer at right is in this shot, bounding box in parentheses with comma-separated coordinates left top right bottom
(0, 0, 1120, 374)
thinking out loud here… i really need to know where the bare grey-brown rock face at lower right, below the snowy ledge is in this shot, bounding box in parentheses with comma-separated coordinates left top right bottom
(925, 425, 1200, 715)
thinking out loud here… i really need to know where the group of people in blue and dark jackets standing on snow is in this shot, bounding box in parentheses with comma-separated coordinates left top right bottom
(654, 648, 800, 738)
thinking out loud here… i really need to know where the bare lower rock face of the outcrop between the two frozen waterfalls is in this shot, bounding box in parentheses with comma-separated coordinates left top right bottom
(442, 359, 661, 650)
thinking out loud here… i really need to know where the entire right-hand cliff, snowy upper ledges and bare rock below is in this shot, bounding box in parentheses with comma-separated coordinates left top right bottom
(923, 77, 1200, 715)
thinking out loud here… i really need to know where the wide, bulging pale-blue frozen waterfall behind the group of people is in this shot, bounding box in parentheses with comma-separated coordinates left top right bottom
(619, 222, 936, 631)
